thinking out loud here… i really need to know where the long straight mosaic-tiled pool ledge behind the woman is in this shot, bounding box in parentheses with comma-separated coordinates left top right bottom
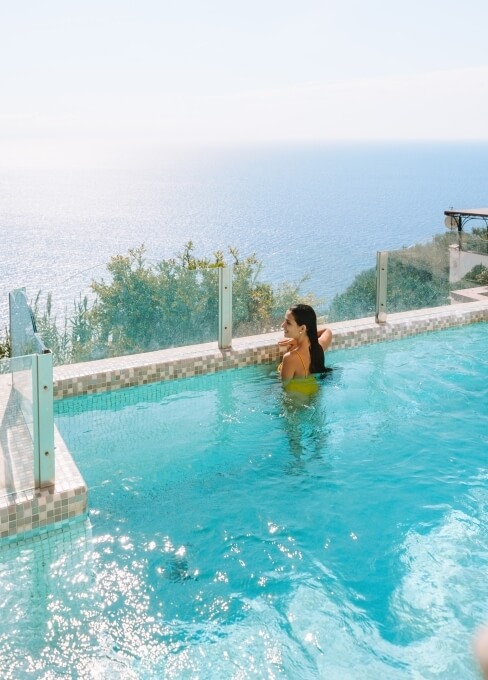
(54, 299, 488, 399)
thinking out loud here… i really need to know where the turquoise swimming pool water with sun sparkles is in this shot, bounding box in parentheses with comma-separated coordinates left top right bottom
(0, 323, 488, 680)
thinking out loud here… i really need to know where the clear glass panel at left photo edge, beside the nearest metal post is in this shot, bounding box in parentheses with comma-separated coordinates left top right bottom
(0, 356, 35, 496)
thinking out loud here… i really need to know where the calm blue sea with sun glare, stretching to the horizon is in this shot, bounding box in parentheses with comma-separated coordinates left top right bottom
(0, 142, 488, 326)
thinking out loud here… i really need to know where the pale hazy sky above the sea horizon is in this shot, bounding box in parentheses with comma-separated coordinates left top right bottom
(0, 0, 488, 167)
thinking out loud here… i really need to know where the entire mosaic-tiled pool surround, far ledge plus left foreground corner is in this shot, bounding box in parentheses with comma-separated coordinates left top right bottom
(0, 296, 488, 540)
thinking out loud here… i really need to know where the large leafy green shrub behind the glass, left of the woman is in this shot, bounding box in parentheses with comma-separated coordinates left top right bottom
(34, 241, 317, 364)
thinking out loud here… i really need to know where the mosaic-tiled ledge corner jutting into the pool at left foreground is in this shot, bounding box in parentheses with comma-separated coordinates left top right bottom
(0, 428, 87, 544)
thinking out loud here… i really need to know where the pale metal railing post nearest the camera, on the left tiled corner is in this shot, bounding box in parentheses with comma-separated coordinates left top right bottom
(32, 351, 55, 488)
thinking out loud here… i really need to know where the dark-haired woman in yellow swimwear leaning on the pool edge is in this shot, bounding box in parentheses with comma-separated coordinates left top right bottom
(278, 304, 332, 393)
